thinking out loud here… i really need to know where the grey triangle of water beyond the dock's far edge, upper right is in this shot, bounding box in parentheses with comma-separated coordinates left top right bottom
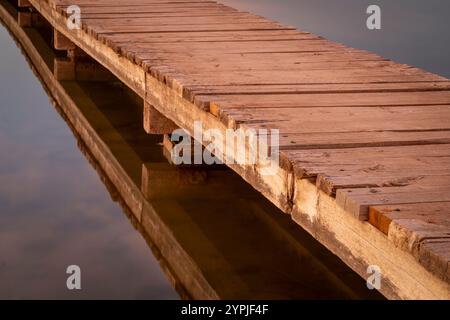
(224, 0, 450, 78)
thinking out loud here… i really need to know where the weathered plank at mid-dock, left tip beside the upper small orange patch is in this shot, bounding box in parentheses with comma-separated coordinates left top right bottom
(218, 105, 450, 134)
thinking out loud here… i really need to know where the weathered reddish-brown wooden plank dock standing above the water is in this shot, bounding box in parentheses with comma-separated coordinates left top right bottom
(5, 0, 450, 299)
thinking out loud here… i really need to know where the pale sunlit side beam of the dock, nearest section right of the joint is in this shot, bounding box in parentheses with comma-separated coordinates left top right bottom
(292, 179, 450, 299)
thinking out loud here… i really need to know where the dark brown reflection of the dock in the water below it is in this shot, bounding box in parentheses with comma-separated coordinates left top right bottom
(0, 0, 379, 299)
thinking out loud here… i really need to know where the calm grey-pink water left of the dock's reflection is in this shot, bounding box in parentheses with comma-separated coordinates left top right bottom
(0, 10, 178, 299)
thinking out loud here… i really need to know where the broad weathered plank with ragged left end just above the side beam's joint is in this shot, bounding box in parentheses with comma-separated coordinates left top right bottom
(283, 141, 450, 194)
